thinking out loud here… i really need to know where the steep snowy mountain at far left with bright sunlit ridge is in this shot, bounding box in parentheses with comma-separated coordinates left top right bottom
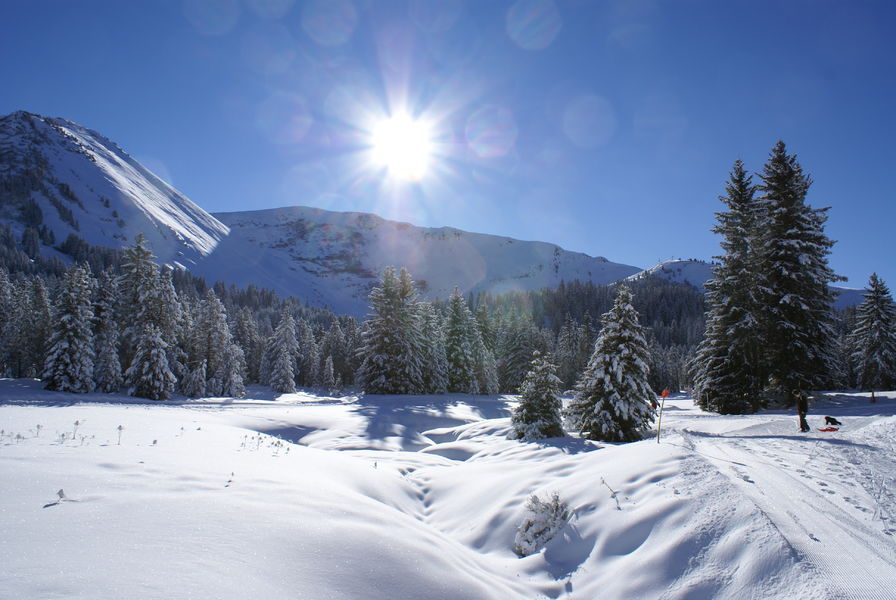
(0, 111, 227, 266)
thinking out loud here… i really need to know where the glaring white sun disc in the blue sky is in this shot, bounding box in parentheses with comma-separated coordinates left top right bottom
(371, 114, 433, 181)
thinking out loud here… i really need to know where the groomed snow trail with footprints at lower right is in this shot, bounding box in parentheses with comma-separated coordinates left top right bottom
(687, 434, 896, 600)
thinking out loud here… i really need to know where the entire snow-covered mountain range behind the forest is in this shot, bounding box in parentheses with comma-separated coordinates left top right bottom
(0, 111, 862, 316)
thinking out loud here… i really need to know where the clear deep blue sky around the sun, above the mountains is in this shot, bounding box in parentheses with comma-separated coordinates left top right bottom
(0, 0, 896, 287)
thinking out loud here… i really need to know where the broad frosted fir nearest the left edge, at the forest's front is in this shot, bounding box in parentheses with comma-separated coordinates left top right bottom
(43, 266, 93, 394)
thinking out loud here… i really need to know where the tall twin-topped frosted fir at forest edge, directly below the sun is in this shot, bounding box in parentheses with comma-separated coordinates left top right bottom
(358, 267, 425, 394)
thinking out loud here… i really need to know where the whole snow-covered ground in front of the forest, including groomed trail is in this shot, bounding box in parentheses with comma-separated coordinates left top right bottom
(0, 380, 896, 600)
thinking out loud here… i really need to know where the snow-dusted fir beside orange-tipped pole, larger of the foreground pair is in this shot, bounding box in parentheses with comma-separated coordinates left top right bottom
(567, 285, 656, 442)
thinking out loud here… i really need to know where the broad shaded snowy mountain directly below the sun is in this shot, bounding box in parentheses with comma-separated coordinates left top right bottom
(198, 206, 638, 314)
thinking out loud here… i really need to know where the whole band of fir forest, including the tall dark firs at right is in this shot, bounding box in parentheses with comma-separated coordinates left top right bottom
(0, 144, 896, 413)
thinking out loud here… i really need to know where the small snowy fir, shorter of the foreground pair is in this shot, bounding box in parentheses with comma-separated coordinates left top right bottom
(510, 350, 563, 442)
